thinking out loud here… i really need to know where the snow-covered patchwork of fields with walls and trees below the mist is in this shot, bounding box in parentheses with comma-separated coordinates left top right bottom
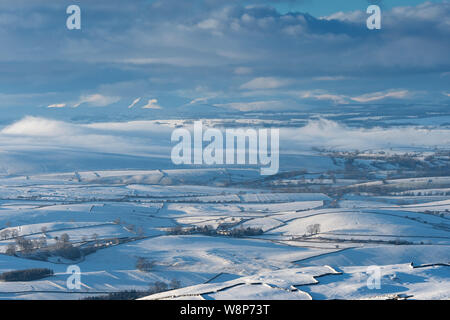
(0, 160, 450, 299)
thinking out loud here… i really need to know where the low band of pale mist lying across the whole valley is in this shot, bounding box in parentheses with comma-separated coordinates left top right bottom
(0, 117, 450, 174)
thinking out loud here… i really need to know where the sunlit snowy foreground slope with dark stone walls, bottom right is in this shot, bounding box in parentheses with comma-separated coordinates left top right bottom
(143, 264, 450, 300)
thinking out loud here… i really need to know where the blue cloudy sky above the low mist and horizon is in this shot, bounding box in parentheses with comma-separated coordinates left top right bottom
(0, 0, 450, 125)
